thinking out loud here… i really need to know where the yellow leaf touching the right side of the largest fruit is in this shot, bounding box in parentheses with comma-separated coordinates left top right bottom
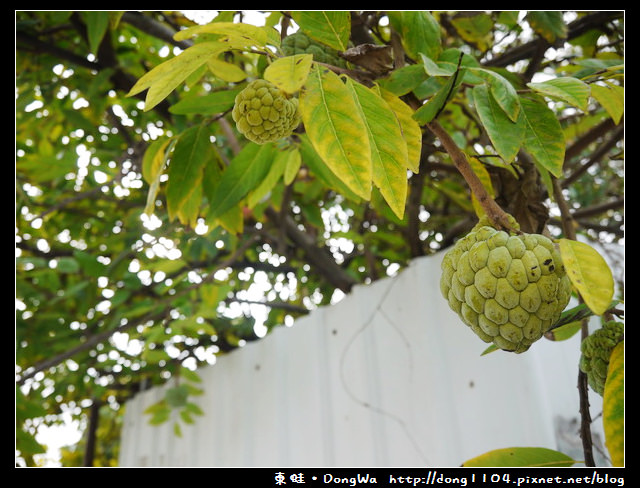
(558, 239, 614, 315)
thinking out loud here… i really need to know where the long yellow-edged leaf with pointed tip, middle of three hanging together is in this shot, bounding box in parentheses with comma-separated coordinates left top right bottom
(347, 79, 408, 219)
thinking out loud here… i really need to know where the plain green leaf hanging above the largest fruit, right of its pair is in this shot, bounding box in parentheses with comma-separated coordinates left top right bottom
(520, 98, 565, 178)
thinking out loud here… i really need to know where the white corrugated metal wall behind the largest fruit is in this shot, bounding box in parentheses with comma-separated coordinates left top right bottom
(120, 254, 603, 467)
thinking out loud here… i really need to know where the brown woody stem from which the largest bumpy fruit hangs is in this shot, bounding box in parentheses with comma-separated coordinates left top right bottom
(426, 120, 519, 233)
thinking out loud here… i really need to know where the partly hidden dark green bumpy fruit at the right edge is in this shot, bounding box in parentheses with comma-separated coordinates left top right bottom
(580, 321, 624, 395)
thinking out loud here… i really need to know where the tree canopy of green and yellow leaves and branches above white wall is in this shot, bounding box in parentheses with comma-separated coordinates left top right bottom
(16, 11, 624, 465)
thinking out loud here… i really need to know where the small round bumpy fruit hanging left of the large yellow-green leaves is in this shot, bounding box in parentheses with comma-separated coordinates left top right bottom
(231, 80, 301, 144)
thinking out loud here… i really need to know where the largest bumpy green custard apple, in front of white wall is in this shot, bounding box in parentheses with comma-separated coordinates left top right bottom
(440, 215, 571, 353)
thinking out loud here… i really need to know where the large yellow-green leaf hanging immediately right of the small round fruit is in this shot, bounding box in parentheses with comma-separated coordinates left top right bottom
(300, 66, 372, 200)
